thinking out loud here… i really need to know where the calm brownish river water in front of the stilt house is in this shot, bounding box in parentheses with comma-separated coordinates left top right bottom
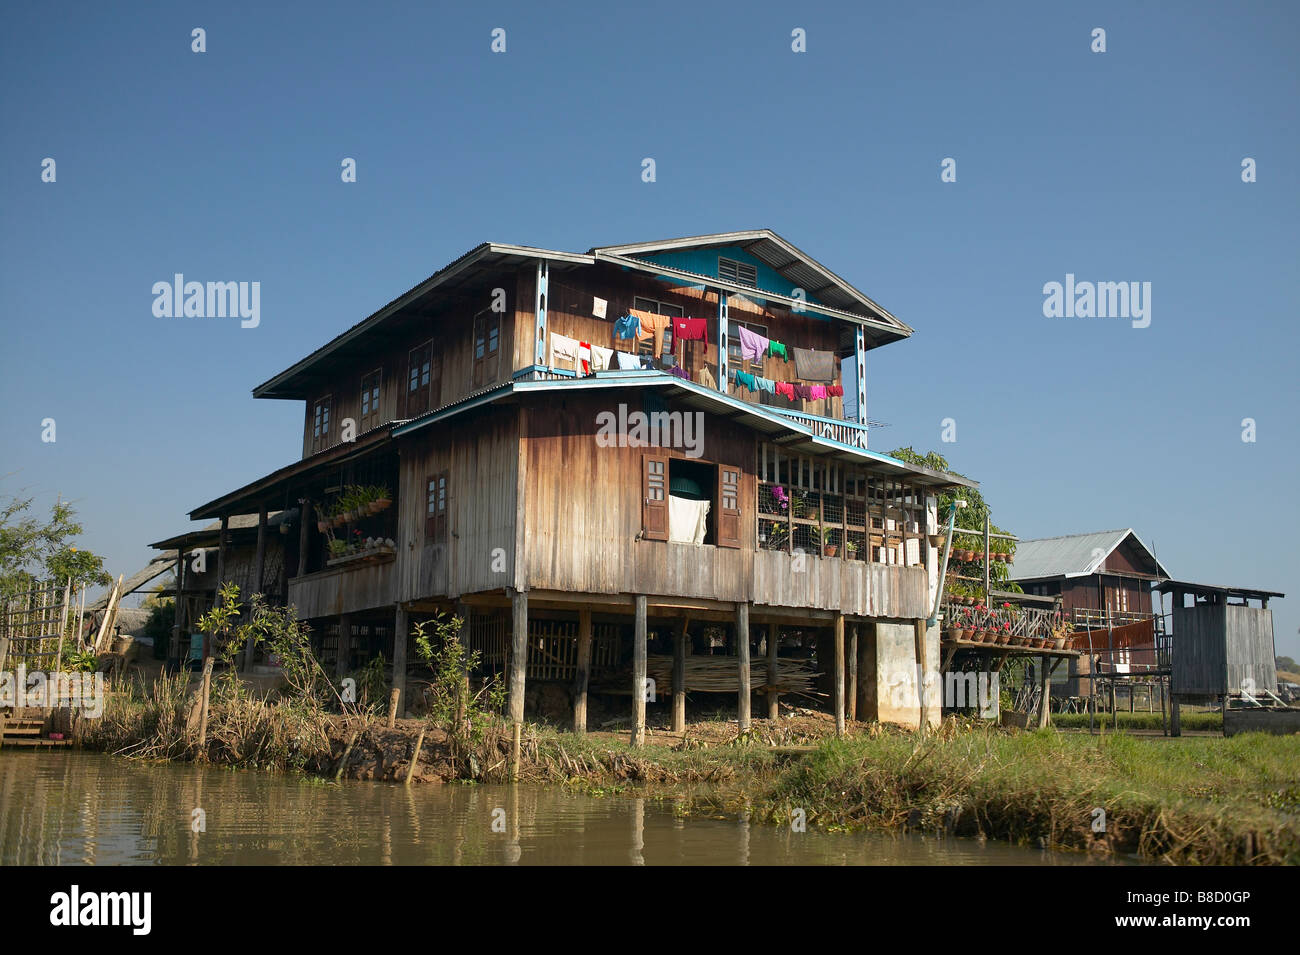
(0, 748, 1118, 865)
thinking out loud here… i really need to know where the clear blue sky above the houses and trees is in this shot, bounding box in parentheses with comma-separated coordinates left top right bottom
(0, 3, 1300, 656)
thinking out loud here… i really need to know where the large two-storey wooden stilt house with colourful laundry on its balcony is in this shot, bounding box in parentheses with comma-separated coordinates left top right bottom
(183, 230, 972, 739)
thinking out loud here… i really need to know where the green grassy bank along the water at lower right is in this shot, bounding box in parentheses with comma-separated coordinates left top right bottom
(764, 729, 1300, 865)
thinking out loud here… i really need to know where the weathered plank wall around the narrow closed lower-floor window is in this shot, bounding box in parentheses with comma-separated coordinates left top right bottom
(395, 407, 519, 600)
